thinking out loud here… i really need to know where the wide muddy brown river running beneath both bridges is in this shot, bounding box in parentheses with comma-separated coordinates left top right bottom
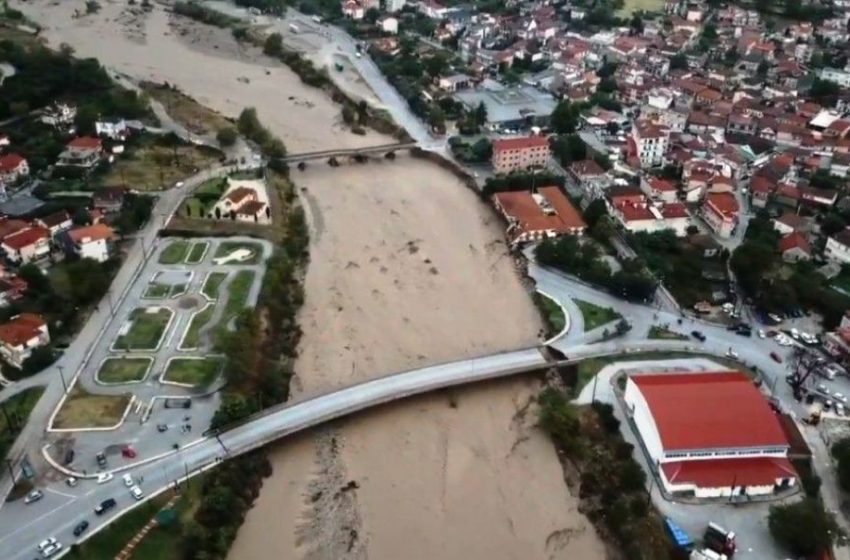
(15, 1, 604, 560)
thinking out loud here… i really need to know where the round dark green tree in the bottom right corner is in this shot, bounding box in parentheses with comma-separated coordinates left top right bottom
(767, 498, 841, 557)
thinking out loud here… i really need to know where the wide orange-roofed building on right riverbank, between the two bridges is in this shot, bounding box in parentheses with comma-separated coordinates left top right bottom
(493, 187, 587, 244)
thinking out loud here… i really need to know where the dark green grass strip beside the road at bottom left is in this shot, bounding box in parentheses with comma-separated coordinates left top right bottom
(65, 492, 174, 560)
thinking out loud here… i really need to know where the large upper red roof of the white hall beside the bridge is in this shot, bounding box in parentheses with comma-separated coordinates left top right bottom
(630, 371, 788, 451)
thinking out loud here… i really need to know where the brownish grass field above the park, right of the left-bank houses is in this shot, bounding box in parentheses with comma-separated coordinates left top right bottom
(99, 142, 218, 191)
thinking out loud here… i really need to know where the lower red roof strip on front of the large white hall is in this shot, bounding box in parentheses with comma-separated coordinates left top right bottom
(661, 457, 797, 488)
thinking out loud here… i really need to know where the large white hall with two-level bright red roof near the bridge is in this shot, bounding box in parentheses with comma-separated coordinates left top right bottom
(624, 371, 797, 498)
